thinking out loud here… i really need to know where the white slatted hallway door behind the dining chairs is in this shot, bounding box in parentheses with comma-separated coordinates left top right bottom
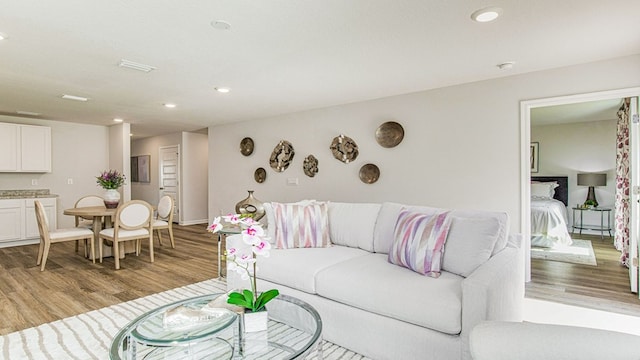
(158, 145, 180, 222)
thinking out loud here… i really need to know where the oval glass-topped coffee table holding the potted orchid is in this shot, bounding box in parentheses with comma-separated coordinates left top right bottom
(109, 294, 322, 360)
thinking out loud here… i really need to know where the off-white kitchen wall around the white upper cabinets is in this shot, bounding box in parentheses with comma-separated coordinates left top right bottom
(0, 115, 109, 227)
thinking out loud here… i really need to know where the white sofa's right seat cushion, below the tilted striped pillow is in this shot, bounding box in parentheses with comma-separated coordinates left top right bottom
(316, 253, 463, 334)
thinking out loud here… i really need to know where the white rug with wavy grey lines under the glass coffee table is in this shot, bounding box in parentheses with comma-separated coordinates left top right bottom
(0, 279, 367, 360)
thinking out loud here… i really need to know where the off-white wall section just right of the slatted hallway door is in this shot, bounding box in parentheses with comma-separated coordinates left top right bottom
(180, 132, 209, 225)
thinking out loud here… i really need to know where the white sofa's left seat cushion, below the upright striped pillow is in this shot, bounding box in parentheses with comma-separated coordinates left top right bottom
(257, 246, 370, 294)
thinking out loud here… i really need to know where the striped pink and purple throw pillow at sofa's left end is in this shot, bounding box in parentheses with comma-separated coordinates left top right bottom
(271, 201, 331, 249)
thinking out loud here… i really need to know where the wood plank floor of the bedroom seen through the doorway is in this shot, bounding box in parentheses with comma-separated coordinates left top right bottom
(526, 234, 640, 316)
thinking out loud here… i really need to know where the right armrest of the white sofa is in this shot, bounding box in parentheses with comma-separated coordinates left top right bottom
(460, 236, 524, 359)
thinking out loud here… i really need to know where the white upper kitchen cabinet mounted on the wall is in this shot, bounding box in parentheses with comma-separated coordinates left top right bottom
(0, 123, 51, 172)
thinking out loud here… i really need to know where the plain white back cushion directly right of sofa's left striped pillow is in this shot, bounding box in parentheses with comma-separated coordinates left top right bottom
(329, 202, 381, 252)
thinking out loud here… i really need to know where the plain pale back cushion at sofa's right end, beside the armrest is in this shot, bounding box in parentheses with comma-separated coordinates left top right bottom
(442, 216, 500, 277)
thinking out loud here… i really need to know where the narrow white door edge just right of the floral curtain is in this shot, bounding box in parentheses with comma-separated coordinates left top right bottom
(629, 97, 640, 293)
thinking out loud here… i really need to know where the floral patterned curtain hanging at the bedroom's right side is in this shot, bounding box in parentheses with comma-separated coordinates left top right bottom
(614, 98, 631, 267)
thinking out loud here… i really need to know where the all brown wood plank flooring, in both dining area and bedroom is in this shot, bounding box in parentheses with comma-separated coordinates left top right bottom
(0, 224, 640, 335)
